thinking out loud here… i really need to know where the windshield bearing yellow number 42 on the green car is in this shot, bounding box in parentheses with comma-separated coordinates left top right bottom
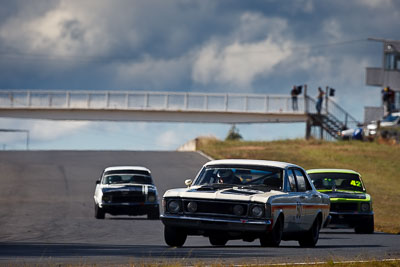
(308, 172, 365, 192)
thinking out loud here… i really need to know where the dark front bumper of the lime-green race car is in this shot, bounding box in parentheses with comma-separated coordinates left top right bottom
(328, 211, 374, 228)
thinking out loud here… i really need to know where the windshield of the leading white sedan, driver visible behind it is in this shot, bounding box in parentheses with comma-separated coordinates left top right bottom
(193, 165, 283, 191)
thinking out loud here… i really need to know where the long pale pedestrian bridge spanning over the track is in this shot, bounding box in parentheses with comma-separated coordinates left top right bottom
(0, 90, 313, 123)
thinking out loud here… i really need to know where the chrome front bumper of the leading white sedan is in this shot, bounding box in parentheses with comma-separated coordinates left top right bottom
(160, 214, 272, 232)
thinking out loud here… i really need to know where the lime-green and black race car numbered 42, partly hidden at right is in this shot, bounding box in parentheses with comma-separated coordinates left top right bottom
(307, 169, 374, 234)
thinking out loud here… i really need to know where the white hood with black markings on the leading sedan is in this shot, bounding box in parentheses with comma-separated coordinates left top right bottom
(164, 186, 286, 203)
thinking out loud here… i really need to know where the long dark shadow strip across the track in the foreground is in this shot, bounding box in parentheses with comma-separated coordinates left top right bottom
(0, 242, 380, 259)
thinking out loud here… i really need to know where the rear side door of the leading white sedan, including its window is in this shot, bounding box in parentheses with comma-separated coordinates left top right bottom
(293, 168, 318, 231)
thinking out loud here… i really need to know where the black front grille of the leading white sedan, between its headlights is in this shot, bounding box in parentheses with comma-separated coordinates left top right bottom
(183, 199, 248, 217)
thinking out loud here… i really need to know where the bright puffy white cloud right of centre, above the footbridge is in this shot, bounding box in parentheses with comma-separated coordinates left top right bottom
(192, 13, 292, 87)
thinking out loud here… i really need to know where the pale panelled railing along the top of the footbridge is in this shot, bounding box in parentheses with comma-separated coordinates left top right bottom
(0, 90, 305, 114)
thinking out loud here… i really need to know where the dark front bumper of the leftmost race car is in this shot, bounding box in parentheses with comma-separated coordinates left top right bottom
(101, 202, 159, 215)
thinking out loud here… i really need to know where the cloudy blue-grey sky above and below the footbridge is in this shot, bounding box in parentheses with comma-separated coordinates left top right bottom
(0, 0, 400, 150)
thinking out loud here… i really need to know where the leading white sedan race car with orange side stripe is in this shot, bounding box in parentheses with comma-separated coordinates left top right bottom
(161, 160, 330, 247)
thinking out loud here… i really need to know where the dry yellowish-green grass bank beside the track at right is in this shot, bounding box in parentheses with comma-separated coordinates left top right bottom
(197, 139, 400, 234)
